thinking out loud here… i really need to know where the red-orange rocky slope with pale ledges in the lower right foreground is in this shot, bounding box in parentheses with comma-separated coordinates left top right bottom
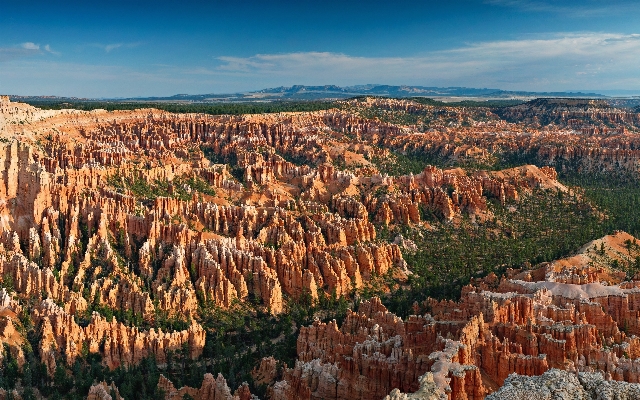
(256, 232, 640, 400)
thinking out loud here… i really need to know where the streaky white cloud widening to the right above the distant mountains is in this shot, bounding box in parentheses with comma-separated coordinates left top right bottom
(209, 33, 640, 90)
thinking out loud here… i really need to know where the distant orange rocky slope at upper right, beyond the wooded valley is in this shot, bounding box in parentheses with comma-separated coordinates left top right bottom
(346, 99, 640, 175)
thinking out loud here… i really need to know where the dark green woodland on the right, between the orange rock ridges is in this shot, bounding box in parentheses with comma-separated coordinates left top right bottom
(374, 147, 640, 317)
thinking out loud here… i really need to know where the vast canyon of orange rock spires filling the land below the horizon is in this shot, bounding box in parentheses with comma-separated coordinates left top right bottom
(0, 97, 640, 400)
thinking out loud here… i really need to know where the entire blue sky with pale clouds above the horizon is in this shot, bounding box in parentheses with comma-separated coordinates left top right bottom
(0, 0, 640, 98)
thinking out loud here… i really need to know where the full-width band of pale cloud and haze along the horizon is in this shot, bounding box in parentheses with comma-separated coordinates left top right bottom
(0, 33, 640, 97)
